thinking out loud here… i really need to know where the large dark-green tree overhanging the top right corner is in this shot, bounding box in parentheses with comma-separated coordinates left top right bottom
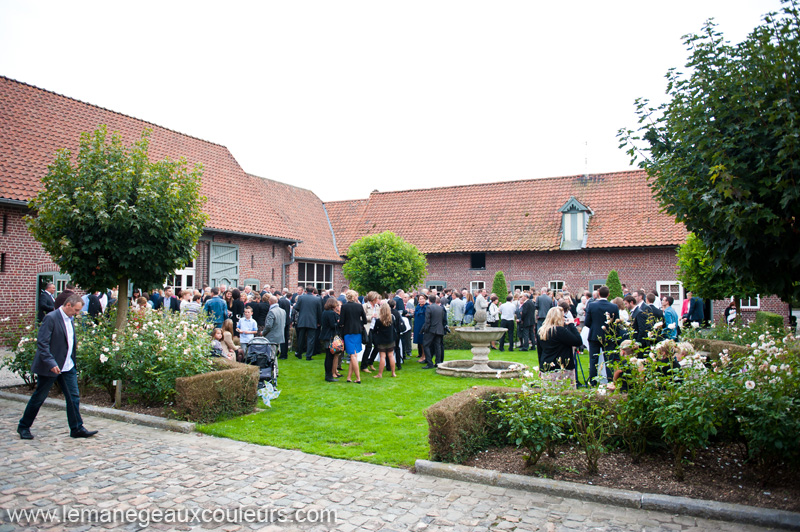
(620, 0, 800, 301)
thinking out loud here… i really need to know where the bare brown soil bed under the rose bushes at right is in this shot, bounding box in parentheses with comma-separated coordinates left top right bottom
(464, 445, 800, 512)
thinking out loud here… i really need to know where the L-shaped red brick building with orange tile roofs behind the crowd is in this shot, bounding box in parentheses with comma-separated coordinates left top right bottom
(0, 77, 788, 324)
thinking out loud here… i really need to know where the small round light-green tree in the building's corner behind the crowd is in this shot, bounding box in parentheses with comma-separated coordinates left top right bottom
(342, 231, 428, 294)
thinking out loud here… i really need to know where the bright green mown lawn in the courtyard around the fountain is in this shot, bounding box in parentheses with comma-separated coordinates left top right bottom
(198, 344, 588, 466)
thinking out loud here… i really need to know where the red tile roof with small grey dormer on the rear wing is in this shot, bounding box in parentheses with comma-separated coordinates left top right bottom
(325, 170, 686, 254)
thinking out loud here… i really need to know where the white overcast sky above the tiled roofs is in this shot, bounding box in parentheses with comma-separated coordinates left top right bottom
(0, 0, 780, 201)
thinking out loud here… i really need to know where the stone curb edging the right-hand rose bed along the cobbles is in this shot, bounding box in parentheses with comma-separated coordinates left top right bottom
(415, 460, 800, 530)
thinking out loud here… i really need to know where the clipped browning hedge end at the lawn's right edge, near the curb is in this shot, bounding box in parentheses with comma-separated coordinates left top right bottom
(425, 386, 514, 464)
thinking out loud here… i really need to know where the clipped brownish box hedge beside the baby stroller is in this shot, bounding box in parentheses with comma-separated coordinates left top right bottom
(175, 358, 259, 423)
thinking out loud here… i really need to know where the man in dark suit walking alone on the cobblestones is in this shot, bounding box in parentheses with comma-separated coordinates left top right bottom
(17, 294, 97, 440)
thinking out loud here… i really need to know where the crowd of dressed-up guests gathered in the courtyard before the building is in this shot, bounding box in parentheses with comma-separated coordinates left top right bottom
(40, 278, 704, 383)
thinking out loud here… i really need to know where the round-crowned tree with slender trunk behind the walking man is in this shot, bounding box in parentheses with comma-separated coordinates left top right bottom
(25, 125, 207, 329)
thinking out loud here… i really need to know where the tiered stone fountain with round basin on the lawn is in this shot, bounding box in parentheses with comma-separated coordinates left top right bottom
(436, 309, 527, 379)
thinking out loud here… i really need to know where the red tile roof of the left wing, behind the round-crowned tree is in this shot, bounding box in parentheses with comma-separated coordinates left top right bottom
(0, 76, 302, 243)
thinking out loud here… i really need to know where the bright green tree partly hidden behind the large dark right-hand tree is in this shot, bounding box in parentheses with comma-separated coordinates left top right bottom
(677, 233, 758, 316)
